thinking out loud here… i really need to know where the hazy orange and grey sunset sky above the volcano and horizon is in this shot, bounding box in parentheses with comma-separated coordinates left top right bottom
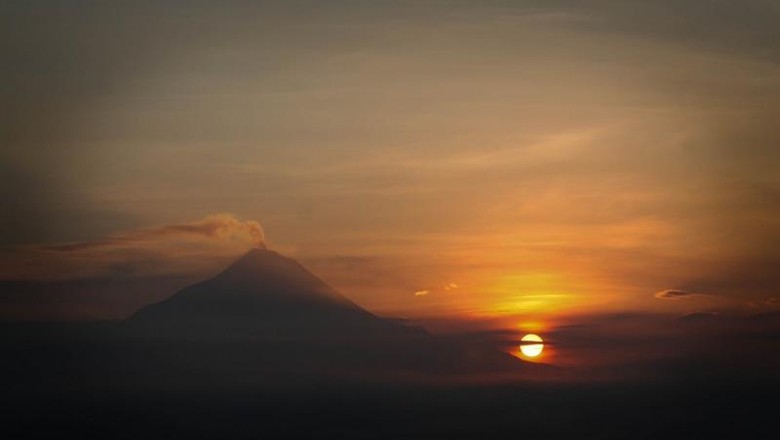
(0, 0, 780, 328)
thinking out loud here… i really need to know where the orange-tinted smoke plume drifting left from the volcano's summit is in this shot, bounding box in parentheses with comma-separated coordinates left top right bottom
(0, 213, 265, 281)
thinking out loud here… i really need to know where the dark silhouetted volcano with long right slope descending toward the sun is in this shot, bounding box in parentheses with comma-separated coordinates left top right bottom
(127, 248, 536, 374)
